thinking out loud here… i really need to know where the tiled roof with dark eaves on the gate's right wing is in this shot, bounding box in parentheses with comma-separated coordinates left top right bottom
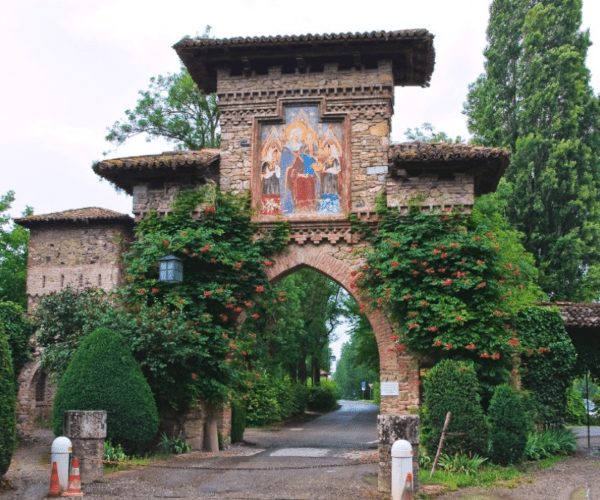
(389, 141, 510, 196)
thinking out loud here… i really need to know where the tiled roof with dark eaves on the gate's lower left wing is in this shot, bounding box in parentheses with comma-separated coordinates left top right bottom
(92, 149, 220, 194)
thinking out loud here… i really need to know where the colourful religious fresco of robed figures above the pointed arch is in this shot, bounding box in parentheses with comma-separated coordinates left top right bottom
(260, 106, 344, 216)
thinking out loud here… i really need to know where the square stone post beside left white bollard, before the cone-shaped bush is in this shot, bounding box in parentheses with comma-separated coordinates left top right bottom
(64, 411, 106, 483)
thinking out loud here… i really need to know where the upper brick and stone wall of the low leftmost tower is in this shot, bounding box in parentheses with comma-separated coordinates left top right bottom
(27, 222, 131, 311)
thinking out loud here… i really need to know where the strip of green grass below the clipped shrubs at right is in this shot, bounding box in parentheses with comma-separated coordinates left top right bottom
(419, 455, 569, 499)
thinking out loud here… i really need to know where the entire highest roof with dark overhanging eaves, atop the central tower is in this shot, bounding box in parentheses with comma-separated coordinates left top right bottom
(173, 29, 435, 93)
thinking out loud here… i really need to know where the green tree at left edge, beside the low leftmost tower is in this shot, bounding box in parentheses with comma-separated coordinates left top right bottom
(0, 191, 33, 309)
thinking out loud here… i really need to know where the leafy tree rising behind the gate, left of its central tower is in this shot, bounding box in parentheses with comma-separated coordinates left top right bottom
(105, 26, 221, 150)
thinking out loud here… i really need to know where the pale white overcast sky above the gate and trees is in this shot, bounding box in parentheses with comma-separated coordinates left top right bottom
(0, 0, 600, 216)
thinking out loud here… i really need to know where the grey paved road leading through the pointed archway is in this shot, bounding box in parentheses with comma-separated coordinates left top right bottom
(0, 401, 386, 500)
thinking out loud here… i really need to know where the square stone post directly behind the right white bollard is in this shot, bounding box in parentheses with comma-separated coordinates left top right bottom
(377, 415, 419, 493)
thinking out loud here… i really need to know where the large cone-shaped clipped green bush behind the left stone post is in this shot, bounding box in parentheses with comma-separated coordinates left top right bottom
(52, 328, 158, 452)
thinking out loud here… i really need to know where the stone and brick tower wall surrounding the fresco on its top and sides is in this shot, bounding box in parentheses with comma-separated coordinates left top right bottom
(217, 61, 394, 211)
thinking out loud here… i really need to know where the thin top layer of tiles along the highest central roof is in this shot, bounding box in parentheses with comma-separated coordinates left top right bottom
(173, 29, 433, 50)
